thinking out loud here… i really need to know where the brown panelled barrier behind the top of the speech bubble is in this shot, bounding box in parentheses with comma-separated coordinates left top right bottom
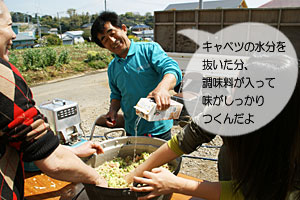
(154, 8, 300, 57)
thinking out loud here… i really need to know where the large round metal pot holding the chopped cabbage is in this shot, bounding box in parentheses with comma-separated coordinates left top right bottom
(84, 136, 181, 200)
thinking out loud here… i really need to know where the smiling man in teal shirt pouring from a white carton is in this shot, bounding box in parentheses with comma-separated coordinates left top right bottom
(91, 12, 182, 140)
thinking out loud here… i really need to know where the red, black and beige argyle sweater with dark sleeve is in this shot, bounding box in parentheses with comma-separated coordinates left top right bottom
(0, 58, 59, 200)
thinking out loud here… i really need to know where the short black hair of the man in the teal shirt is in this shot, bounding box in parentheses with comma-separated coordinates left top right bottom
(91, 11, 122, 48)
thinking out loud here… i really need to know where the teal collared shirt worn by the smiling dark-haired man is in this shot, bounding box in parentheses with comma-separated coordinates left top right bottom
(108, 41, 182, 136)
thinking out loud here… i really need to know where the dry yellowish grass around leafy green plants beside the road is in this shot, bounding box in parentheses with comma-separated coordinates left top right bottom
(10, 43, 111, 86)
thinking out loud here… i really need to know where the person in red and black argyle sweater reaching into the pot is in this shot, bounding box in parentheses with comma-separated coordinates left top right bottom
(0, 0, 107, 199)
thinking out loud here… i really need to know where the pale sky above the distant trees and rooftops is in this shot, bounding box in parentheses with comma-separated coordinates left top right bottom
(4, 0, 270, 16)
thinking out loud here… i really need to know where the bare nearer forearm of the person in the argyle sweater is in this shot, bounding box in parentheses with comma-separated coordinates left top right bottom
(35, 145, 101, 184)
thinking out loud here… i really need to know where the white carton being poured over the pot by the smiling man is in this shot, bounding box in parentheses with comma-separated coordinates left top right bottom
(134, 98, 183, 121)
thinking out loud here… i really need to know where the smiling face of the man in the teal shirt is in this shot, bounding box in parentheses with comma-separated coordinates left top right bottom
(98, 22, 130, 58)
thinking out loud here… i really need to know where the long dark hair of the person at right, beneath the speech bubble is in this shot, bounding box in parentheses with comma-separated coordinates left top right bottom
(223, 53, 300, 200)
